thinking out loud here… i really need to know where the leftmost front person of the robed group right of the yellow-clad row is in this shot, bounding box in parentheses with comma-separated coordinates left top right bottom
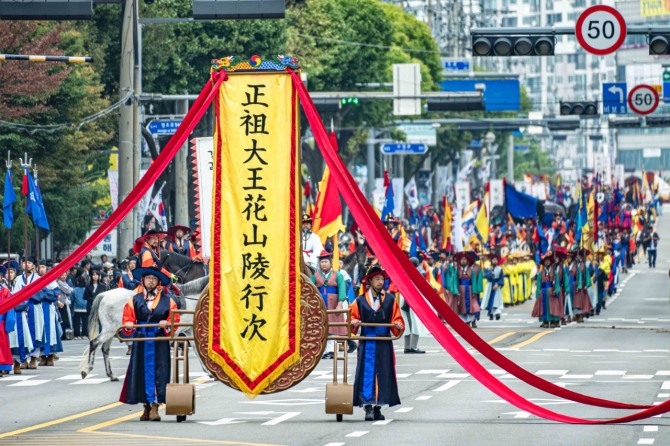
(531, 252, 563, 328)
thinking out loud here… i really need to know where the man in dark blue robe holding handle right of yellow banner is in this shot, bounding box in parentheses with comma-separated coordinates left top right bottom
(351, 265, 405, 421)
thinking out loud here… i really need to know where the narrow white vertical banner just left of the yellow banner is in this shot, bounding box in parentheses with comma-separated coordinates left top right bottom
(191, 137, 214, 259)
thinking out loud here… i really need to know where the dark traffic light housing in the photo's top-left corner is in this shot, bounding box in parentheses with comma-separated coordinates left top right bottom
(0, 0, 93, 20)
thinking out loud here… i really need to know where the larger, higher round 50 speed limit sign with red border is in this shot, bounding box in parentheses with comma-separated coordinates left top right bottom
(575, 5, 626, 56)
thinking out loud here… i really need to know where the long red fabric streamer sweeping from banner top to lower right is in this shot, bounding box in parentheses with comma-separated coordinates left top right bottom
(291, 68, 670, 424)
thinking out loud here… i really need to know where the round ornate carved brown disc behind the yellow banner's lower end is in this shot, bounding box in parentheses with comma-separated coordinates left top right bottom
(193, 274, 328, 394)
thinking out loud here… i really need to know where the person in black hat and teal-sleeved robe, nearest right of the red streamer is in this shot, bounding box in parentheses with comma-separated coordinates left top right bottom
(454, 251, 483, 328)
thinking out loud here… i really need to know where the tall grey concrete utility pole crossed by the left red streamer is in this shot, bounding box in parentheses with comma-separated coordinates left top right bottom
(117, 0, 138, 259)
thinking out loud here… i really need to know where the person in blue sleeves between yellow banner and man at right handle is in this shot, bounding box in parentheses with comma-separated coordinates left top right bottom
(310, 251, 347, 359)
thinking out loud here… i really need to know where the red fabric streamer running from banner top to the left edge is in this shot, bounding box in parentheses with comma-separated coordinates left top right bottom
(0, 72, 228, 314)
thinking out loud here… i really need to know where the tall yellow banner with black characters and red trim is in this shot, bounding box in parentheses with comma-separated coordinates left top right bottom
(208, 73, 301, 395)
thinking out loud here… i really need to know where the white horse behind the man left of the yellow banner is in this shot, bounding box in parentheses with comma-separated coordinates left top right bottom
(79, 276, 209, 381)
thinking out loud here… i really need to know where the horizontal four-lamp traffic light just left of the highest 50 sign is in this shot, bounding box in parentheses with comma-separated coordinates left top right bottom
(471, 31, 555, 57)
